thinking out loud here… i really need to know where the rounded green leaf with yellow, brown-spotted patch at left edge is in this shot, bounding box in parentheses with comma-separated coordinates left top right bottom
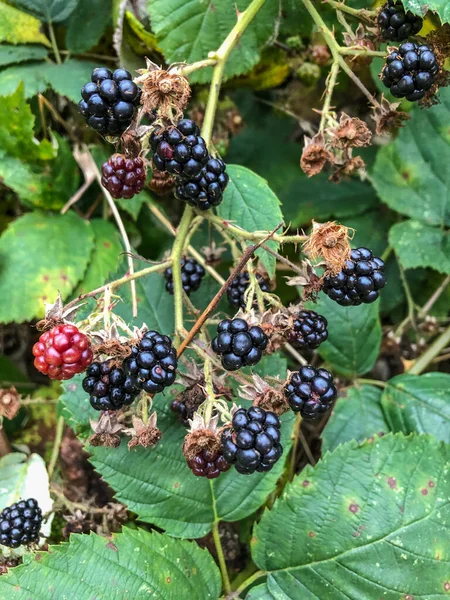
(0, 212, 94, 323)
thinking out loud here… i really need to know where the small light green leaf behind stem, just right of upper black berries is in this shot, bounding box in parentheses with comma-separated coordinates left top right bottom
(217, 165, 283, 277)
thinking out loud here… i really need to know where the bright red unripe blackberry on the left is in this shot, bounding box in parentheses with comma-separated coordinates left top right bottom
(33, 325, 93, 380)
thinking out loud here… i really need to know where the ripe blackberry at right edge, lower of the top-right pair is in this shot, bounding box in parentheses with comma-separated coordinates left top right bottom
(381, 42, 439, 102)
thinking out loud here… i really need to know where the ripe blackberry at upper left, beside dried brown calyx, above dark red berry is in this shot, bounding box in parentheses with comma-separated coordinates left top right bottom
(78, 68, 141, 136)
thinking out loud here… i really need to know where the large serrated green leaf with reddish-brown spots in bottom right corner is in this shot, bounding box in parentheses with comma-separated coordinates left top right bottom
(252, 434, 450, 600)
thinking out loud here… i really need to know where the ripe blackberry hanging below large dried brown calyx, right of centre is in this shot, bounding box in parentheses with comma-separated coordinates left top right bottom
(323, 248, 386, 306)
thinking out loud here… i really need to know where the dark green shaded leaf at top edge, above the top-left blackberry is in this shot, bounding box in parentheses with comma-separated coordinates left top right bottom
(66, 0, 111, 54)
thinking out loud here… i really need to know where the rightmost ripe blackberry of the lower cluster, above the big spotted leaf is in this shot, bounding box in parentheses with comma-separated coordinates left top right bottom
(284, 365, 337, 419)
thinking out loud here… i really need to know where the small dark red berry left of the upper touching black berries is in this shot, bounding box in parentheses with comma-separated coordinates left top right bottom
(102, 154, 147, 199)
